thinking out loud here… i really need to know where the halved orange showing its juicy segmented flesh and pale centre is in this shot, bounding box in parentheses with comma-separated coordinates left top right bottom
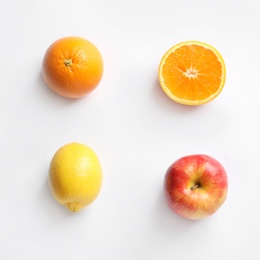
(158, 41, 226, 105)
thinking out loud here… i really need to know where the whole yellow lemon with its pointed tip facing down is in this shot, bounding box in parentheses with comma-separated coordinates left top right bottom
(49, 142, 102, 212)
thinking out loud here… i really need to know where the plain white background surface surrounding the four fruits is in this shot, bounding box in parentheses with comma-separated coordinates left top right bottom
(0, 0, 260, 260)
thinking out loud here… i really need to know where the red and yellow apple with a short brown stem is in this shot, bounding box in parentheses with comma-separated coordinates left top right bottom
(164, 154, 228, 219)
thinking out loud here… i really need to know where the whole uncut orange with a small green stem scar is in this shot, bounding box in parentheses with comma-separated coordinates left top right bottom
(42, 36, 103, 98)
